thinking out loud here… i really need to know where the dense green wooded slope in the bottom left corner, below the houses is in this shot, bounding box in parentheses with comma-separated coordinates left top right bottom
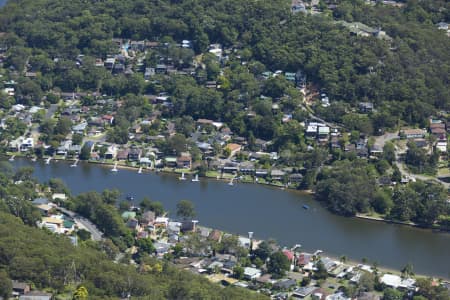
(0, 212, 264, 299)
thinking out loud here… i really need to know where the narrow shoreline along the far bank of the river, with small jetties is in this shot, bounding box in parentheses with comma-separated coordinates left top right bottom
(5, 154, 450, 233)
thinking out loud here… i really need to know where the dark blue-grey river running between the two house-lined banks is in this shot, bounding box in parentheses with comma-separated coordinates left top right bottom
(7, 159, 450, 278)
